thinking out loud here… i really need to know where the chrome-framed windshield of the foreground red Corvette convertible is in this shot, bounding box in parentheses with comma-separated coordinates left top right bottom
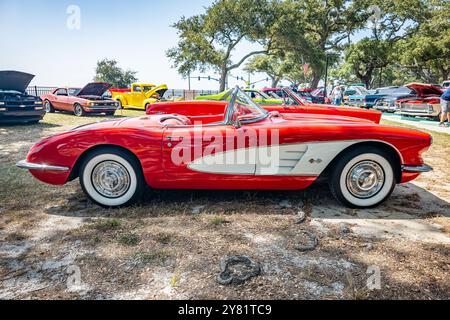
(226, 87, 269, 123)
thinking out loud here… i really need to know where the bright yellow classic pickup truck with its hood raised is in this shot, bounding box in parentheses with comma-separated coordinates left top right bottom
(109, 83, 168, 110)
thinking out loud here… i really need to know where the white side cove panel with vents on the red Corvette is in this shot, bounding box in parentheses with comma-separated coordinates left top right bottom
(188, 140, 360, 176)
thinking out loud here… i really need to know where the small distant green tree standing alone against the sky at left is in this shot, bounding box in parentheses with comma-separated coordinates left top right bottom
(94, 59, 137, 88)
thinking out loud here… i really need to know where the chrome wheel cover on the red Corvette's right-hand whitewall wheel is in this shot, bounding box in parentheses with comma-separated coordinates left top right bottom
(346, 161, 385, 199)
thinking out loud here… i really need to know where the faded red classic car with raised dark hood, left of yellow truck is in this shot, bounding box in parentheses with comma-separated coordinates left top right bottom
(41, 82, 118, 117)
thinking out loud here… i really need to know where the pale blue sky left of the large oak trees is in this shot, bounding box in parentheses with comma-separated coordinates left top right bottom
(0, 0, 265, 89)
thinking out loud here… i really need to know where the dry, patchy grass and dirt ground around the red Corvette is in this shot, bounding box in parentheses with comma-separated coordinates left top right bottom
(0, 112, 450, 299)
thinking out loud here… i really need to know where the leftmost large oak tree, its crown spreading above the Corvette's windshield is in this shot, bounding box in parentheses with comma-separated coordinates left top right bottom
(167, 0, 275, 91)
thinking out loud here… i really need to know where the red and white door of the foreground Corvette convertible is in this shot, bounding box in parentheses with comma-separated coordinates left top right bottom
(162, 124, 257, 182)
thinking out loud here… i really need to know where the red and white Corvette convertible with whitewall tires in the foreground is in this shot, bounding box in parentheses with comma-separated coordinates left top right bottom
(17, 88, 432, 208)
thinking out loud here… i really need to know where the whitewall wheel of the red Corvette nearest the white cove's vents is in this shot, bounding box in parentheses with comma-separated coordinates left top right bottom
(329, 147, 396, 208)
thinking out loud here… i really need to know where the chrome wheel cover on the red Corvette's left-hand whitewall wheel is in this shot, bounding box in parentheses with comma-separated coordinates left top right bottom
(91, 161, 131, 198)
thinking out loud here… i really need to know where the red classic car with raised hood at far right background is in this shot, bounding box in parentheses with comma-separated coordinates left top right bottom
(397, 83, 443, 120)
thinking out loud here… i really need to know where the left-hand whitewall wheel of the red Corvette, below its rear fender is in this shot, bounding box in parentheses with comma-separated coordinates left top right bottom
(80, 148, 144, 208)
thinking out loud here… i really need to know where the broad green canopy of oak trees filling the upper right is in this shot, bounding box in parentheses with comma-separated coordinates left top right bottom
(167, 0, 450, 89)
